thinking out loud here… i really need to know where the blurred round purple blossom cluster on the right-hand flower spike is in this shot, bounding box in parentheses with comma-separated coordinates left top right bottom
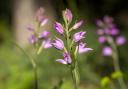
(96, 16, 126, 56)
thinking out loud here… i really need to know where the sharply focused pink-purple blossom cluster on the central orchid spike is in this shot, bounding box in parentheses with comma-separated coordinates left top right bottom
(52, 9, 92, 64)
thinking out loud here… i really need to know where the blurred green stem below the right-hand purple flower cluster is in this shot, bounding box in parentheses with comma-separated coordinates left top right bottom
(108, 37, 127, 89)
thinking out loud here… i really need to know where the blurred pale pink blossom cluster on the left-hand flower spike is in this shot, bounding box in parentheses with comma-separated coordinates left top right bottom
(27, 8, 52, 48)
